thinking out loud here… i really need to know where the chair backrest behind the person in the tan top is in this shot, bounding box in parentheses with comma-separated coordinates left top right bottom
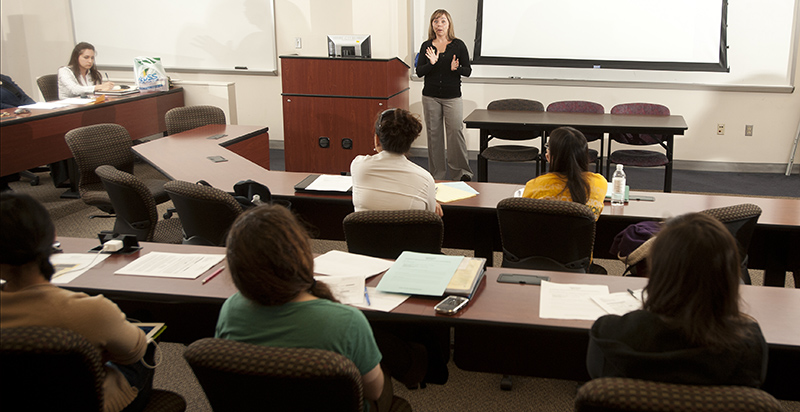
(0, 326, 105, 411)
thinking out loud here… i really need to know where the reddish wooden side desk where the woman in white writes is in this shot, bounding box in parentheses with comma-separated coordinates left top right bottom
(0, 88, 183, 176)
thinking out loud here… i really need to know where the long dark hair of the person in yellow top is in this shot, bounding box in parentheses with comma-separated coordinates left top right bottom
(547, 127, 591, 204)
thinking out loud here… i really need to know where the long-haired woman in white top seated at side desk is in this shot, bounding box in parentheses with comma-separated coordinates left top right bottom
(58, 42, 114, 99)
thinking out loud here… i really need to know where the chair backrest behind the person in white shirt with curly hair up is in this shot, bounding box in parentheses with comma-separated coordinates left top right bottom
(342, 210, 444, 259)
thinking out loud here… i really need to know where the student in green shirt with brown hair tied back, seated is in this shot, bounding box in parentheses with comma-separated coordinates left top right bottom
(211, 205, 392, 409)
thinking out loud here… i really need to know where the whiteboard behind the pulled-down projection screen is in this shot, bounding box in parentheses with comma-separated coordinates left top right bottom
(410, 0, 798, 92)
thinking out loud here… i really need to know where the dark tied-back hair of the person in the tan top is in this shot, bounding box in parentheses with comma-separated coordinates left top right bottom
(0, 192, 56, 280)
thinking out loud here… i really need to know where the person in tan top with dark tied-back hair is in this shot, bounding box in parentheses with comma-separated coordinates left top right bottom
(0, 192, 153, 412)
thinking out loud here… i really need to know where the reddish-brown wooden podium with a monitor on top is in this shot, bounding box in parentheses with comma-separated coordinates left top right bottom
(281, 56, 409, 174)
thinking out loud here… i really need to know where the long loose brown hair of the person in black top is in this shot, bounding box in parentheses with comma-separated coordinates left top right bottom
(644, 213, 750, 347)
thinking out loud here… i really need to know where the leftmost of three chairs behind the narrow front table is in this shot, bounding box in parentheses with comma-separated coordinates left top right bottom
(478, 99, 544, 182)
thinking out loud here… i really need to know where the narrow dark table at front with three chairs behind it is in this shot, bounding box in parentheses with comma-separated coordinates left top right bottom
(464, 109, 689, 192)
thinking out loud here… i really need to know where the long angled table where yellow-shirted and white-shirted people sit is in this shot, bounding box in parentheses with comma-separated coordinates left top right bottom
(133, 125, 800, 286)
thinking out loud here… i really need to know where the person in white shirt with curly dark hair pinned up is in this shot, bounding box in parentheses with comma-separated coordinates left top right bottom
(350, 109, 442, 216)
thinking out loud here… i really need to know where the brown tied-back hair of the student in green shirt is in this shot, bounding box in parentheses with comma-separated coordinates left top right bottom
(227, 205, 336, 306)
